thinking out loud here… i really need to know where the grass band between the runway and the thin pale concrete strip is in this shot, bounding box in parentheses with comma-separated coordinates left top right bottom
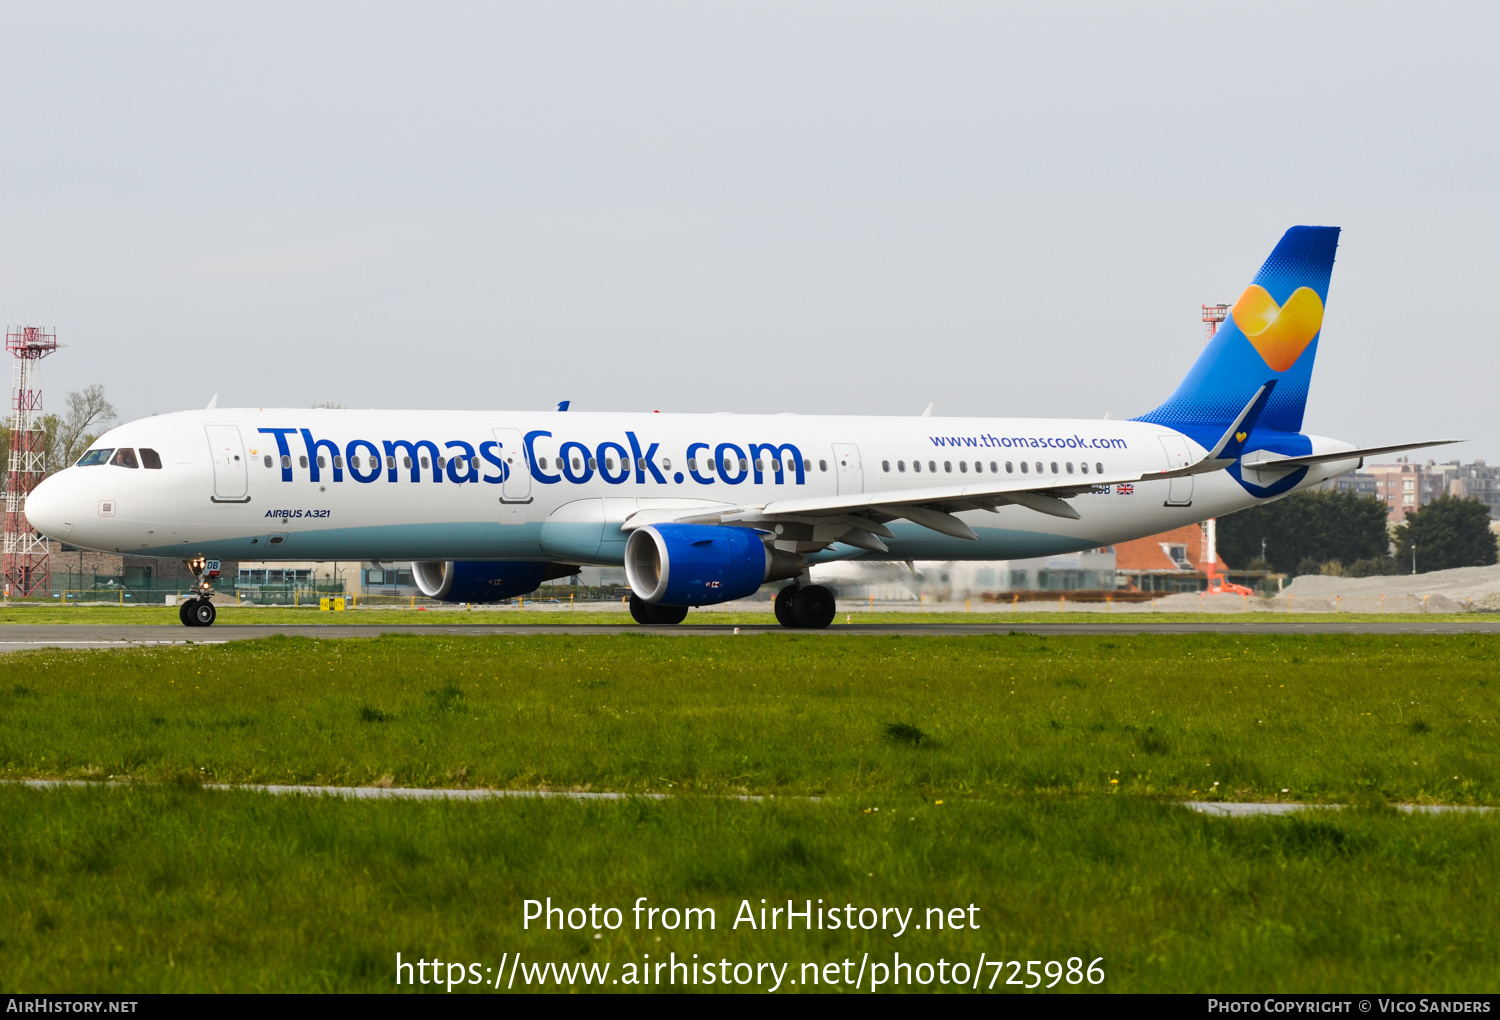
(0, 633, 1500, 804)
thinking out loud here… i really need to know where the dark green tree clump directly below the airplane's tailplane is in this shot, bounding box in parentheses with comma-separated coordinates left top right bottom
(1218, 489, 1391, 573)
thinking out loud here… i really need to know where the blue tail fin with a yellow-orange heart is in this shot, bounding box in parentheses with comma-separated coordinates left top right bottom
(1136, 227, 1338, 432)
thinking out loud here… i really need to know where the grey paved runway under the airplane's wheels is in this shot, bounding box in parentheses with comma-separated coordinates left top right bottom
(0, 620, 1500, 653)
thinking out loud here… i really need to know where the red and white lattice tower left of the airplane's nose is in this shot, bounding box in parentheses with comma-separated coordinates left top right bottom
(0, 326, 57, 599)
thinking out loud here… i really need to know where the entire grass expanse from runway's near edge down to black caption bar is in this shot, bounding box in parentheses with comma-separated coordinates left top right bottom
(0, 633, 1500, 992)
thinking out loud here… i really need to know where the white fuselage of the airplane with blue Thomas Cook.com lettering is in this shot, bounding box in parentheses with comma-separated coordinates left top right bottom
(27, 410, 1355, 564)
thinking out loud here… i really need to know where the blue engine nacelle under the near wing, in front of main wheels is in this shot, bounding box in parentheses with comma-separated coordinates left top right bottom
(626, 524, 803, 606)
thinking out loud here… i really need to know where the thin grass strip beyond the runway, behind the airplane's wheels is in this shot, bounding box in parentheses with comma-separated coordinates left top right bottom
(0, 603, 1500, 633)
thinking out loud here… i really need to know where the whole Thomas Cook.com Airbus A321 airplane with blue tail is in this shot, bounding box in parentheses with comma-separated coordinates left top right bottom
(26, 227, 1452, 629)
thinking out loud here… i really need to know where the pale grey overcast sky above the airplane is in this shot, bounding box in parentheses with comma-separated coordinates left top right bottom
(0, 0, 1500, 462)
